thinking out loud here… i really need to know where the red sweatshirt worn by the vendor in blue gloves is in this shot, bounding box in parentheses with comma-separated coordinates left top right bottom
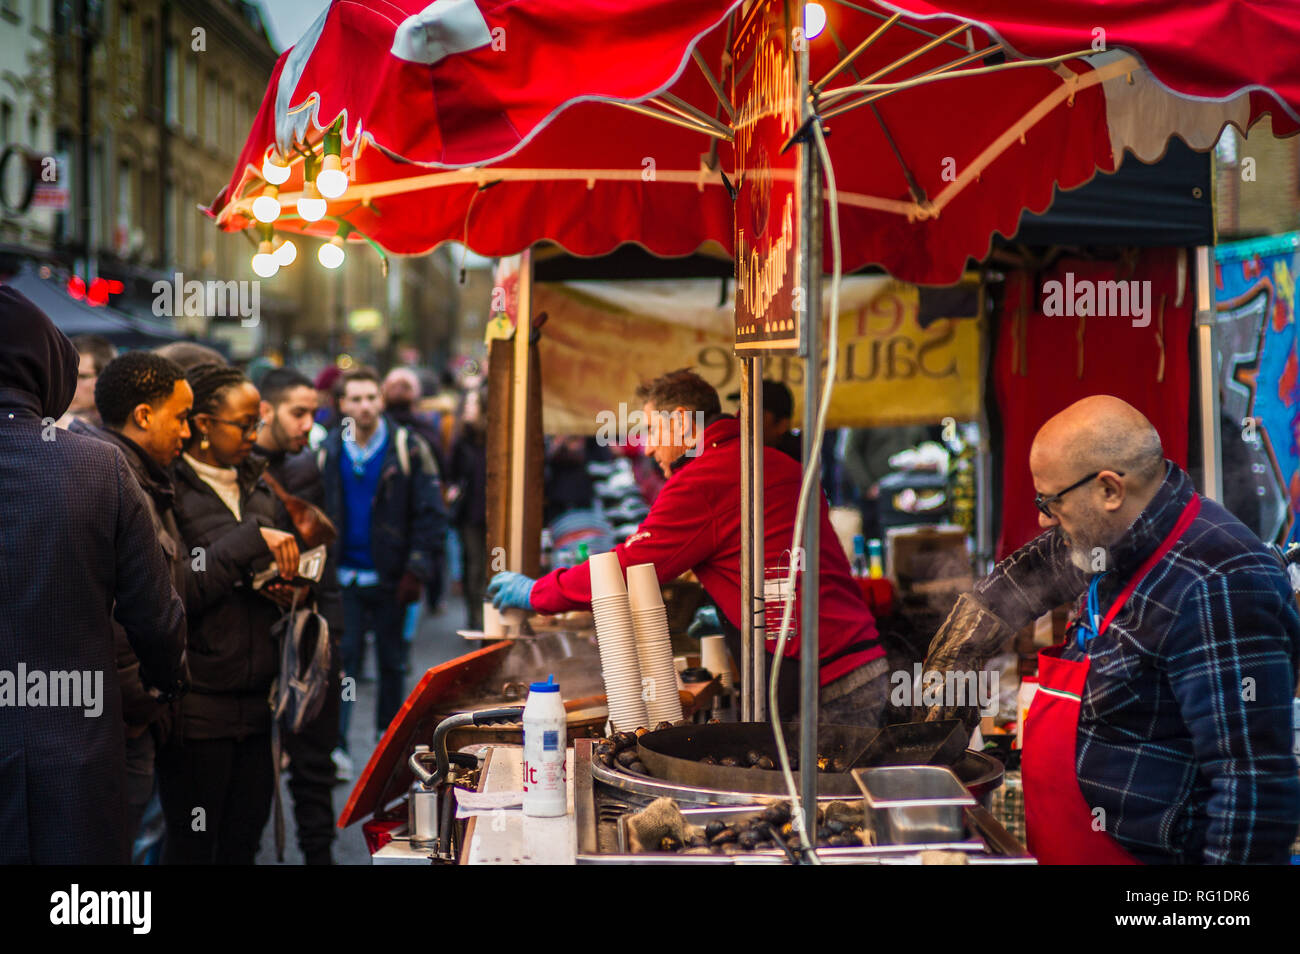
(532, 417, 884, 685)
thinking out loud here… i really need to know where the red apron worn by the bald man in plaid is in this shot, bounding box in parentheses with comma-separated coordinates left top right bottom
(1021, 495, 1201, 864)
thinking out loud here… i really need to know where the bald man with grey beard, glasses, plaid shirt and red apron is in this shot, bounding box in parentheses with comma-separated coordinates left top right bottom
(926, 395, 1300, 864)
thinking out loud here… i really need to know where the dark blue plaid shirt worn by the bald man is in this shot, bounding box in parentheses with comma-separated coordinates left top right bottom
(974, 463, 1300, 864)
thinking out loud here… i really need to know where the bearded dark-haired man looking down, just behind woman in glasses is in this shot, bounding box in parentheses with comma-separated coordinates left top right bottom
(252, 368, 343, 864)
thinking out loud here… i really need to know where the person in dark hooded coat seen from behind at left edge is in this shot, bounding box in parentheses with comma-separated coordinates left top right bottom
(0, 285, 185, 864)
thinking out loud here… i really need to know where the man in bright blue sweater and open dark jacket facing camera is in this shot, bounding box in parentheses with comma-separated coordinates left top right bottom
(317, 368, 447, 750)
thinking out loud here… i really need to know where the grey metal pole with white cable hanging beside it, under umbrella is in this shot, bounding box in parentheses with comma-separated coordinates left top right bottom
(798, 44, 822, 811)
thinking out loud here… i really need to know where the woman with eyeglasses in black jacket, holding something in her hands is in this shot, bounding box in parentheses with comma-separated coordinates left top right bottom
(157, 364, 298, 864)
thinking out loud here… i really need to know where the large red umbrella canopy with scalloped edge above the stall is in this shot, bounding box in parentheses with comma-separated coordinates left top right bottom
(212, 0, 1300, 283)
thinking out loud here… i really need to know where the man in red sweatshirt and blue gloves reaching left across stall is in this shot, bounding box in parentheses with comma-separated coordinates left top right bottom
(488, 369, 889, 727)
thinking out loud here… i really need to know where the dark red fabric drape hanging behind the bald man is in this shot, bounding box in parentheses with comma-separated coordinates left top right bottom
(993, 248, 1193, 559)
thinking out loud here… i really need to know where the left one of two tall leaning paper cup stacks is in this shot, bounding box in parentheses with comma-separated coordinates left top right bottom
(589, 551, 650, 732)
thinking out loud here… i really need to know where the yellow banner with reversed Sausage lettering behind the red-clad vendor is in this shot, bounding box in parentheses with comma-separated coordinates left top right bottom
(533, 277, 983, 434)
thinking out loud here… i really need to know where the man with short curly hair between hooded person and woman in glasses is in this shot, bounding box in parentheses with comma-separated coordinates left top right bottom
(82, 351, 194, 840)
